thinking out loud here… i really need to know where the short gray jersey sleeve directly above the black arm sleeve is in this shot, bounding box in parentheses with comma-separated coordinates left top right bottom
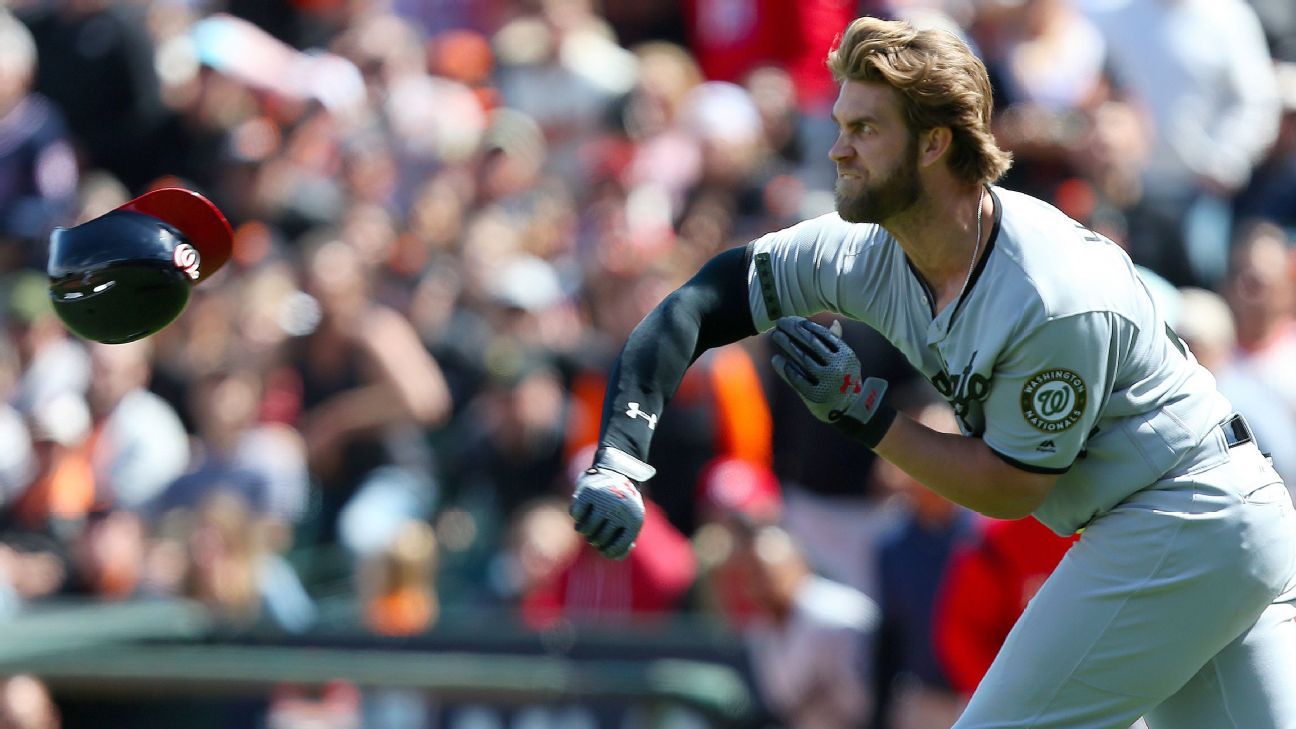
(746, 213, 875, 332)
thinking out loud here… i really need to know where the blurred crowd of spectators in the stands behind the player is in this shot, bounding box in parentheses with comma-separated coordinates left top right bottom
(0, 0, 1296, 729)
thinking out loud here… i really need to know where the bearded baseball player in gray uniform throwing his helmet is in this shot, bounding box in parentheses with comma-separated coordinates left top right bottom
(572, 18, 1296, 729)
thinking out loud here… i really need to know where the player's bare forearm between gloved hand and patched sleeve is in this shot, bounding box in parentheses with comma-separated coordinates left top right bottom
(874, 415, 1056, 519)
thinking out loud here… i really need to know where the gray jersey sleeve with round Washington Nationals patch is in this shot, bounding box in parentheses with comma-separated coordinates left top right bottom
(982, 313, 1125, 473)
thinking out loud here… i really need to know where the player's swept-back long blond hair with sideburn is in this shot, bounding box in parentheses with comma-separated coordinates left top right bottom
(828, 17, 1012, 184)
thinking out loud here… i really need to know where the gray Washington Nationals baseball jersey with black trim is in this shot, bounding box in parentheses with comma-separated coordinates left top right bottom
(748, 188, 1230, 534)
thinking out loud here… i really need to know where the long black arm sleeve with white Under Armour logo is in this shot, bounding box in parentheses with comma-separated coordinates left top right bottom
(599, 245, 756, 463)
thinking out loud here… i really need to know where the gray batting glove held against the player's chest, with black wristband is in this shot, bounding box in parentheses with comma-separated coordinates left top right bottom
(771, 317, 896, 448)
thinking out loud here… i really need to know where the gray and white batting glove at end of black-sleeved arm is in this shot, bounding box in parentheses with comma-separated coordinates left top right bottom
(569, 448, 656, 559)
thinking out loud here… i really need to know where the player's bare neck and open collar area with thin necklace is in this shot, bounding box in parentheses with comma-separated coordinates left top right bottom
(883, 185, 994, 306)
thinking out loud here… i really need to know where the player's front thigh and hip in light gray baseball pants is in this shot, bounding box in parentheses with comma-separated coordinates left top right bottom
(956, 453, 1296, 729)
